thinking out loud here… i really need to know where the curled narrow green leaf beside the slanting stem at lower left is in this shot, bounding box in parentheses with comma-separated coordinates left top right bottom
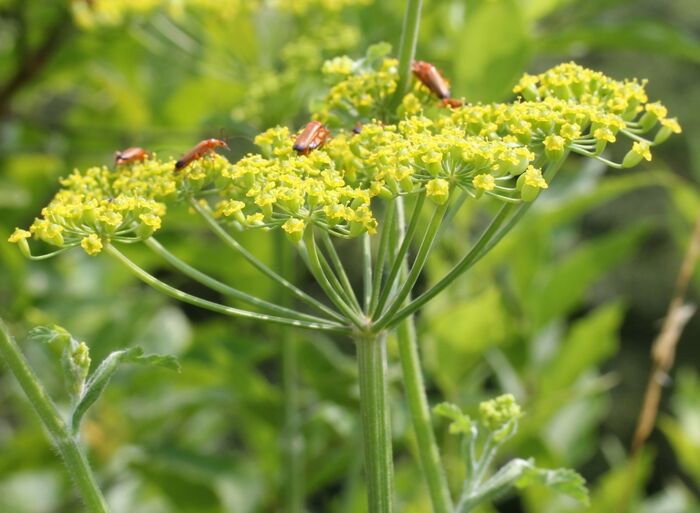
(71, 347, 180, 433)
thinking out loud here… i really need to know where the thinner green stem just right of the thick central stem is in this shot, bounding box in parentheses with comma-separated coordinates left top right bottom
(396, 198, 453, 513)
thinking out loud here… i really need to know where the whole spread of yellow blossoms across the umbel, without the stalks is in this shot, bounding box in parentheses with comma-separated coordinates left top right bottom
(10, 58, 680, 254)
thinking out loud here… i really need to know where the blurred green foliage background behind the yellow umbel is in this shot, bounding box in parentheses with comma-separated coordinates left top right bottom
(0, 0, 700, 513)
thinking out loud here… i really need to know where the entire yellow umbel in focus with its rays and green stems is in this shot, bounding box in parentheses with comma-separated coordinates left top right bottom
(10, 25, 680, 513)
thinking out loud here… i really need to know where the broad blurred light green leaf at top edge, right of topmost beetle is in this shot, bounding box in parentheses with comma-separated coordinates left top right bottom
(453, 0, 530, 101)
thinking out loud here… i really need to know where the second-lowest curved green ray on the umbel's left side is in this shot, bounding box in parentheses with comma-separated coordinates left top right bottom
(144, 237, 342, 327)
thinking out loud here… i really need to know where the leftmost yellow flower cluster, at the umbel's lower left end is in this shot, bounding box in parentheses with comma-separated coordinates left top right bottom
(9, 160, 177, 255)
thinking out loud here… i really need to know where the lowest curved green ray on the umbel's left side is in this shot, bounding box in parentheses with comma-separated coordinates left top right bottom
(105, 245, 350, 333)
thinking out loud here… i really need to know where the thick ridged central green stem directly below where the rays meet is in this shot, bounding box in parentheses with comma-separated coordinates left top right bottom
(355, 332, 394, 513)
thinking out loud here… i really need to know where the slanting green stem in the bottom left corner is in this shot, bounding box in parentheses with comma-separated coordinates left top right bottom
(0, 319, 109, 513)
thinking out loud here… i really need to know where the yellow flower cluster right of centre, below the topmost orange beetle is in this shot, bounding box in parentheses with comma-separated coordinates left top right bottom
(324, 116, 546, 204)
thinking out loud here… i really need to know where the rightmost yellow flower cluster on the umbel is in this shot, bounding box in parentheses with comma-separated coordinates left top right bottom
(506, 63, 681, 162)
